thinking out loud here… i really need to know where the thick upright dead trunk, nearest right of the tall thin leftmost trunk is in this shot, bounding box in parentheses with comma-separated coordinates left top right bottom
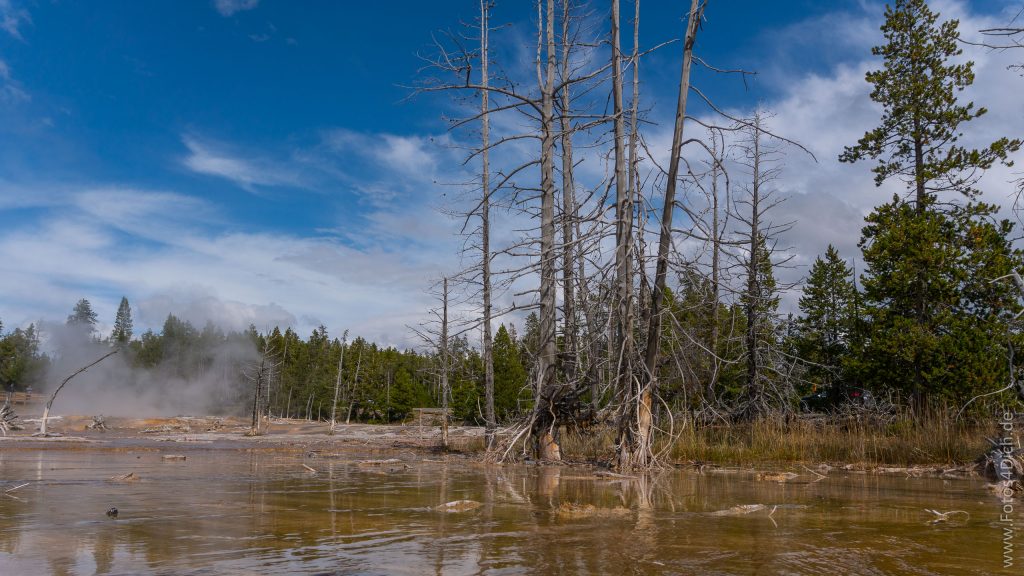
(532, 0, 561, 460)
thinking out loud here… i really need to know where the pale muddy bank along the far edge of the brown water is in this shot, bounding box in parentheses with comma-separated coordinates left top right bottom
(0, 415, 1003, 483)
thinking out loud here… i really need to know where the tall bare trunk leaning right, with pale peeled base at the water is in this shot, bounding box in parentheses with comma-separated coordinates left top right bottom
(618, 0, 707, 469)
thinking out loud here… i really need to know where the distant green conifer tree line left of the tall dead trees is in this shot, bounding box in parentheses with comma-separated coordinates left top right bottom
(0, 297, 532, 422)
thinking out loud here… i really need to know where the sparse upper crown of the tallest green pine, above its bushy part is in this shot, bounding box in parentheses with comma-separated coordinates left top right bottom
(840, 0, 1021, 206)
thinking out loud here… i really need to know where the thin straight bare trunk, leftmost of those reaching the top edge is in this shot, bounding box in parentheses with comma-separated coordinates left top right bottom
(480, 0, 498, 450)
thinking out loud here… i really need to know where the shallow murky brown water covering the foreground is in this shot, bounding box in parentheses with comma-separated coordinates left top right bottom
(0, 447, 1024, 575)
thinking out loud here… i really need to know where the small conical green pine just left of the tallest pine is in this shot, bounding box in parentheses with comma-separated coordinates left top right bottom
(797, 244, 857, 394)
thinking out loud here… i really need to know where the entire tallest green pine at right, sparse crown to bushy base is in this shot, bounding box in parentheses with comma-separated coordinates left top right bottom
(840, 0, 1021, 409)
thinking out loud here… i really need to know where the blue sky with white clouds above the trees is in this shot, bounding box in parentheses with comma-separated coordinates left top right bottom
(0, 0, 1024, 344)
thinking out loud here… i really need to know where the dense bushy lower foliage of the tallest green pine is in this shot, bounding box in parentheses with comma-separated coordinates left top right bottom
(855, 198, 1024, 408)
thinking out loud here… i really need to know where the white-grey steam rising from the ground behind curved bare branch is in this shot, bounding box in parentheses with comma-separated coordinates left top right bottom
(38, 323, 259, 417)
